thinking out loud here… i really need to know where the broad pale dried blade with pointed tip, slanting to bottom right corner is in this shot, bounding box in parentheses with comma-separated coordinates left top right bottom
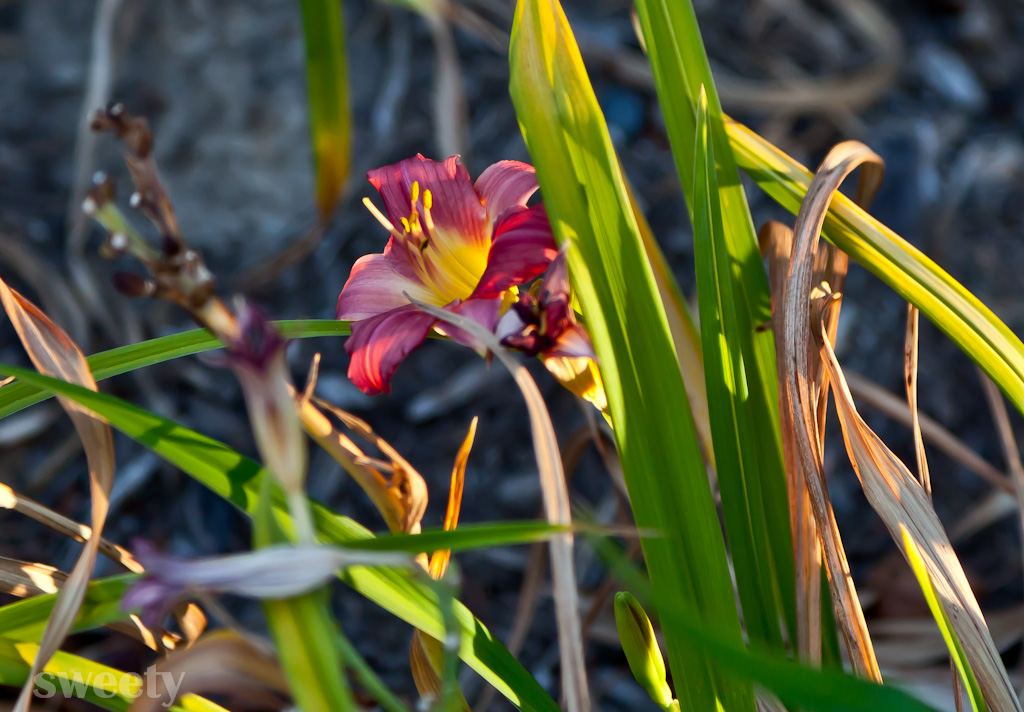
(818, 298, 1021, 710)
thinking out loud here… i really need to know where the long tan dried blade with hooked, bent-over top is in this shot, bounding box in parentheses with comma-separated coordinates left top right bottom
(774, 141, 883, 682)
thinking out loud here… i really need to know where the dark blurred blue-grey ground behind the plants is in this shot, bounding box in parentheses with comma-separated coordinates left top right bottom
(0, 0, 1024, 710)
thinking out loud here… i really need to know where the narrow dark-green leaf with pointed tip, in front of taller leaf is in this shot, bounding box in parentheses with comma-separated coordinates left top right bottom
(692, 93, 785, 651)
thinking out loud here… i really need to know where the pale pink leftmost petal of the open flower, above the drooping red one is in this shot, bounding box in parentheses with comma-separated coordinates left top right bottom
(338, 254, 436, 320)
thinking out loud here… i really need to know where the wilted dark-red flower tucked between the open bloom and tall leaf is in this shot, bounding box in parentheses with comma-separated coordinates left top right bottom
(498, 250, 608, 412)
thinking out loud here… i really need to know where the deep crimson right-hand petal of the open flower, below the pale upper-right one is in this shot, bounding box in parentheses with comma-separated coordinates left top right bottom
(473, 205, 558, 297)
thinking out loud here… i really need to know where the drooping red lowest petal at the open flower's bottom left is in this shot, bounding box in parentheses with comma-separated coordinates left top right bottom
(345, 304, 437, 395)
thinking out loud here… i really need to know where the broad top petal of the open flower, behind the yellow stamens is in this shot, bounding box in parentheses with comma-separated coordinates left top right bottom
(367, 154, 490, 251)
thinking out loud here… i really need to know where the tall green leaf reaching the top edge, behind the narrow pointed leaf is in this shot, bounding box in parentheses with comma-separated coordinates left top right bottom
(636, 0, 796, 647)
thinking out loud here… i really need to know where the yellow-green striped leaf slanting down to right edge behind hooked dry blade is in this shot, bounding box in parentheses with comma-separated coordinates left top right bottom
(728, 122, 1024, 426)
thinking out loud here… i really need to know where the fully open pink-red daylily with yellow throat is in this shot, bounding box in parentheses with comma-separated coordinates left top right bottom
(338, 155, 557, 395)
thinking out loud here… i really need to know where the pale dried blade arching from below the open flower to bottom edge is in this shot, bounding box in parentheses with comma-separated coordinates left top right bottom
(407, 295, 590, 712)
